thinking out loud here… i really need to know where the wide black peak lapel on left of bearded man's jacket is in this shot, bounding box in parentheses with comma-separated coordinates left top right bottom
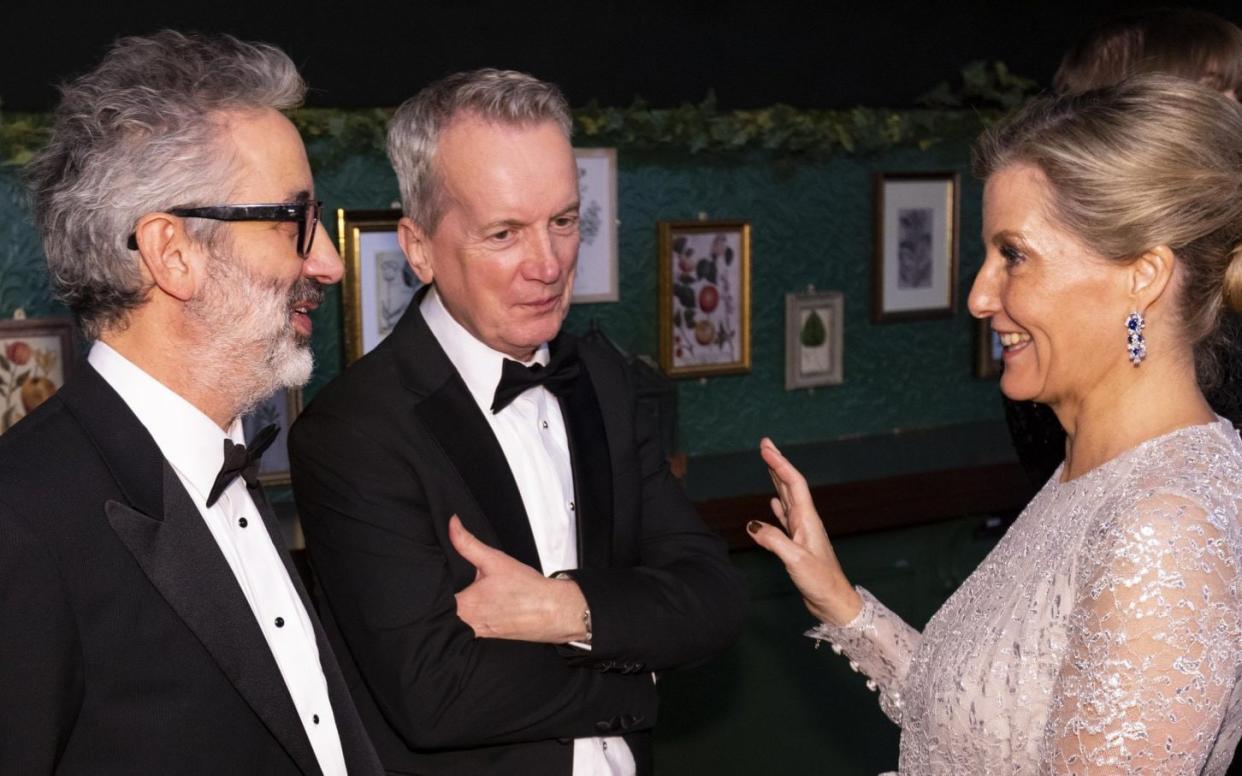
(104, 464, 320, 774)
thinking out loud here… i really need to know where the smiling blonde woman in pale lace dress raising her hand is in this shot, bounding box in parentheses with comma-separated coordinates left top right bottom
(748, 74, 1242, 775)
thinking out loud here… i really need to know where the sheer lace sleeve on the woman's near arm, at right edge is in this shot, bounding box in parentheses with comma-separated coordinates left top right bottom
(1041, 494, 1242, 774)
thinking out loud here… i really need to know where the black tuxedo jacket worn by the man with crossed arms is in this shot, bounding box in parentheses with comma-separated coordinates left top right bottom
(289, 294, 745, 775)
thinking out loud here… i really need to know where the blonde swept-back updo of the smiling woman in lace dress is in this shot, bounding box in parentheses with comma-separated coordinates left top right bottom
(974, 73, 1242, 386)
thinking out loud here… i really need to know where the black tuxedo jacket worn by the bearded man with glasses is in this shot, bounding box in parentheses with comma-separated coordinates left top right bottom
(0, 363, 381, 776)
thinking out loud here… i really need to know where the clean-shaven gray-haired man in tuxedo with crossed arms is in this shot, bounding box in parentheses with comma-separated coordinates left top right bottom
(289, 70, 744, 776)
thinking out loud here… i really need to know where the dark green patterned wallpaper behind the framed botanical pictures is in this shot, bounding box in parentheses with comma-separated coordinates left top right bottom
(0, 140, 1001, 456)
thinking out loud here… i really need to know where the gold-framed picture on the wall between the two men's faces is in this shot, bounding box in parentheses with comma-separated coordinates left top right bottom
(337, 209, 422, 364)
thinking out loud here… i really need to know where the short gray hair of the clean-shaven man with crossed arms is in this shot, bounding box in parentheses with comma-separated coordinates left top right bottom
(388, 68, 574, 235)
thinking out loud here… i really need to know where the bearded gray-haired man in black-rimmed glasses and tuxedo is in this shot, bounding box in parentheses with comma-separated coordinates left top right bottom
(0, 31, 381, 776)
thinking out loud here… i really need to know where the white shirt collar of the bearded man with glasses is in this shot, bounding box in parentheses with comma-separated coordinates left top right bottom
(87, 341, 245, 500)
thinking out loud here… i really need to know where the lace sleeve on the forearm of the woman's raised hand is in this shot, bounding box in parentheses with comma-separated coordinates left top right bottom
(806, 587, 919, 725)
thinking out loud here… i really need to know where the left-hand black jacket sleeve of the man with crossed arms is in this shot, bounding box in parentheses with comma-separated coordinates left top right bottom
(289, 406, 656, 749)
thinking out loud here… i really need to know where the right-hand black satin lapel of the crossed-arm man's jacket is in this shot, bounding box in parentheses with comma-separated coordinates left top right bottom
(560, 347, 612, 569)
